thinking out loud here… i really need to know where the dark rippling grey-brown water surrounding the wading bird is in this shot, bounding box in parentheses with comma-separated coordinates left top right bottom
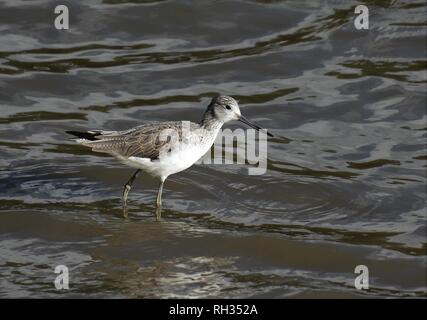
(0, 0, 427, 298)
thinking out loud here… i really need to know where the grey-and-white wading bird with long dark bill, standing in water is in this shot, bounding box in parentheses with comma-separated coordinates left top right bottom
(66, 96, 273, 218)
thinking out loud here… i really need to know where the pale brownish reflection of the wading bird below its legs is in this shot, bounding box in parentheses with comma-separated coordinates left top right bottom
(82, 206, 242, 298)
